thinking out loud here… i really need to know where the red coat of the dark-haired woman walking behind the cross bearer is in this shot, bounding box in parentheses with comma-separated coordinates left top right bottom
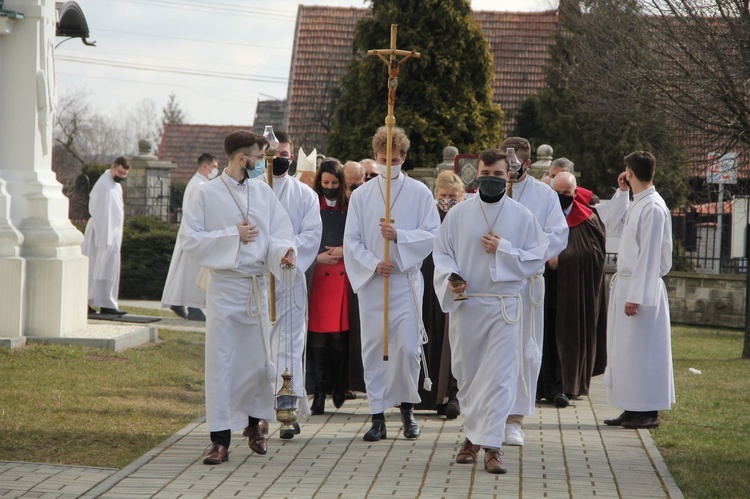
(308, 196, 350, 333)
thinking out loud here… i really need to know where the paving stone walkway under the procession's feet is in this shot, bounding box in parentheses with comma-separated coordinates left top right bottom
(0, 378, 682, 499)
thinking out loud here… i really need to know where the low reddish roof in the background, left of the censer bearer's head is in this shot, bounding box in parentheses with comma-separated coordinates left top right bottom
(156, 124, 249, 184)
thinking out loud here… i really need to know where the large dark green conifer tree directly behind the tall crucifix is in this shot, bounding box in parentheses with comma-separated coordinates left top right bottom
(326, 0, 504, 168)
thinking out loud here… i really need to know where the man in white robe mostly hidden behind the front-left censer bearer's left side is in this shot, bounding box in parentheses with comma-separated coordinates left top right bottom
(161, 153, 219, 321)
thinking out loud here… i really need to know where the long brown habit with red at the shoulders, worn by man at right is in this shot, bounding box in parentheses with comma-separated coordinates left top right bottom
(537, 199, 607, 402)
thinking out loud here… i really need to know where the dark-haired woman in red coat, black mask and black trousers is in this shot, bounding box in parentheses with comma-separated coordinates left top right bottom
(308, 158, 349, 414)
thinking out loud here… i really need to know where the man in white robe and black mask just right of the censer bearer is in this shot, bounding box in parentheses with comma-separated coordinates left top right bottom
(264, 131, 323, 439)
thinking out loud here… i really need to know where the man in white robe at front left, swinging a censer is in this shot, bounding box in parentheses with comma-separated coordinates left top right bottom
(179, 130, 295, 464)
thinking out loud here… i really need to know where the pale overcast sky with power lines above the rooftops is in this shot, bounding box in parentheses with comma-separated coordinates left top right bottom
(56, 0, 557, 129)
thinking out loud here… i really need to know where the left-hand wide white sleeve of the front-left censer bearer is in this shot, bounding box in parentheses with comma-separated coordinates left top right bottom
(178, 189, 240, 270)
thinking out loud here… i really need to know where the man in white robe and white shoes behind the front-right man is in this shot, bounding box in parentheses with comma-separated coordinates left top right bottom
(500, 137, 568, 446)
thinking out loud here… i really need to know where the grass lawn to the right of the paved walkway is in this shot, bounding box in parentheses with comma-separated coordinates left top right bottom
(651, 326, 750, 497)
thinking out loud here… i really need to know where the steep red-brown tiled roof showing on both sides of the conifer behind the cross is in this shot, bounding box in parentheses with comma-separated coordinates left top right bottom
(287, 5, 558, 151)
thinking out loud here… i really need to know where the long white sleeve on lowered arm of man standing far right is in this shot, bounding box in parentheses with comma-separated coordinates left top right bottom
(626, 203, 672, 307)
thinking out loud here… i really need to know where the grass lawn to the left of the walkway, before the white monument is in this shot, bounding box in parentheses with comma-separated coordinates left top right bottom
(0, 330, 204, 468)
